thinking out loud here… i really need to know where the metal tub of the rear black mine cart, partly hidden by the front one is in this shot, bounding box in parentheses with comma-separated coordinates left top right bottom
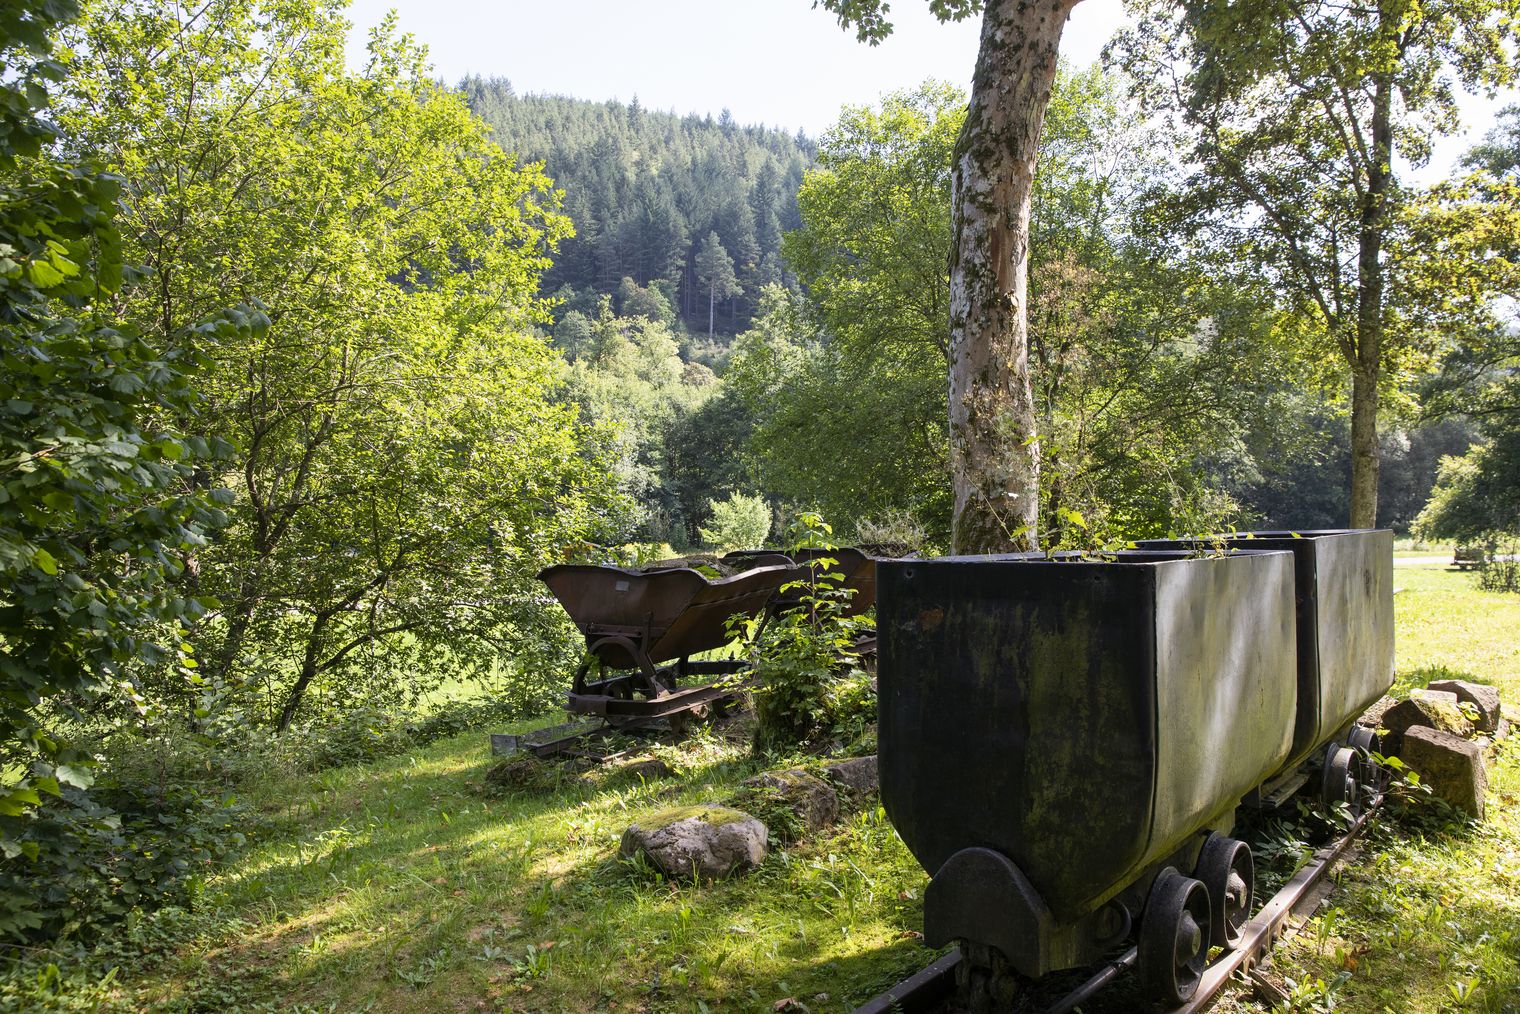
(1137, 529, 1394, 766)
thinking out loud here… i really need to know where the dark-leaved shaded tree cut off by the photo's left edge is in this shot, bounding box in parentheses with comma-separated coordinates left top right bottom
(0, 0, 263, 857)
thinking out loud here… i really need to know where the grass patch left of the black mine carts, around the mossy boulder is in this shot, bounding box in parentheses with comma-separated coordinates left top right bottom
(41, 734, 924, 1011)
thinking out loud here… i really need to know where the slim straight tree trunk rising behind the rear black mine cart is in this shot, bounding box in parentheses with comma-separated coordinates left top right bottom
(1350, 67, 1394, 528)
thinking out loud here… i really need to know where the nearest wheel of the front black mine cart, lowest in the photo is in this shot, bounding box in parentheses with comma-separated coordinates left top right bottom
(1138, 867, 1210, 1006)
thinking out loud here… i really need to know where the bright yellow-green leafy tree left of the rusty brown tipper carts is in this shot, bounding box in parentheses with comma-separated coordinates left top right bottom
(64, 0, 610, 727)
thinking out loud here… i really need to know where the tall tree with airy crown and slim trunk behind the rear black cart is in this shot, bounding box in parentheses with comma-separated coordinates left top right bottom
(1114, 0, 1520, 528)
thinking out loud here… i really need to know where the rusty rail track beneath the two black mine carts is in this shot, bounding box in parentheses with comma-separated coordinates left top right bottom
(854, 795, 1382, 1014)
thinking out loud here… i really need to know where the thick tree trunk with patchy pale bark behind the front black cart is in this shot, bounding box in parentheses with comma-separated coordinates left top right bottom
(950, 0, 1078, 553)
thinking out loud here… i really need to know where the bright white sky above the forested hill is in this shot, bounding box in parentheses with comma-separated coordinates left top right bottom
(350, 0, 1520, 175)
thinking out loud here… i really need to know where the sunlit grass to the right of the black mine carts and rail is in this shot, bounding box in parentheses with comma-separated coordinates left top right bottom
(1218, 567, 1520, 1014)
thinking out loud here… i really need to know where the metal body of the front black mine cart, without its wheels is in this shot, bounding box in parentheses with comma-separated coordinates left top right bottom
(877, 552, 1297, 978)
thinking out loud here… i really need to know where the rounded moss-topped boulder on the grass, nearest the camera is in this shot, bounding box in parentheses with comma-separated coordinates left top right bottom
(619, 803, 768, 880)
